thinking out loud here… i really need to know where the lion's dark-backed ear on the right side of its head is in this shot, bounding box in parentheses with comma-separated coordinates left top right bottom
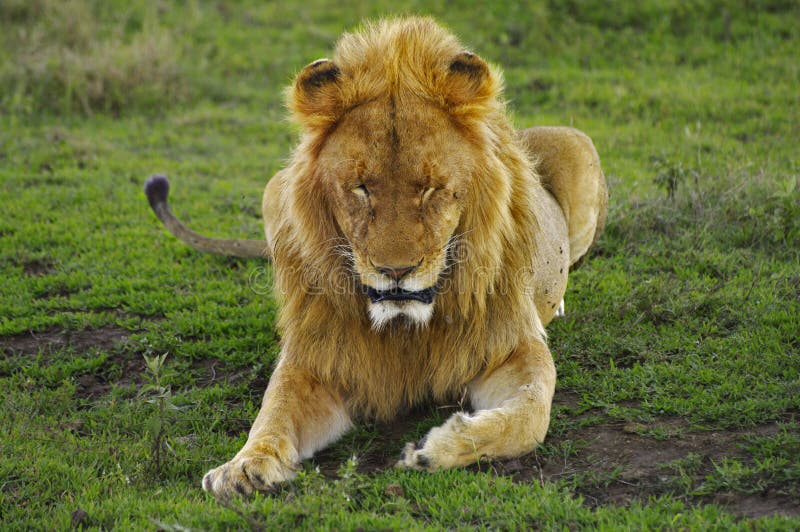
(444, 52, 500, 106)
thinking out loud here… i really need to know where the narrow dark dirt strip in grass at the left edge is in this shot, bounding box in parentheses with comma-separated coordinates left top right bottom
(0, 326, 130, 355)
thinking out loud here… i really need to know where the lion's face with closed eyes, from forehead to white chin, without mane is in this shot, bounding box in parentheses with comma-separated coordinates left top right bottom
(317, 98, 472, 328)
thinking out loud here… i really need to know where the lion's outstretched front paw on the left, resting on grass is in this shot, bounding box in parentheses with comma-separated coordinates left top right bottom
(203, 454, 295, 500)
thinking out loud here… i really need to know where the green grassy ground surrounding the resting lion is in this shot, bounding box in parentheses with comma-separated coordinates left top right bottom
(0, 0, 800, 530)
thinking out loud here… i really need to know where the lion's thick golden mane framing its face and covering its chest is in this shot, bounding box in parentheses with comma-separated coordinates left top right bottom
(265, 18, 544, 419)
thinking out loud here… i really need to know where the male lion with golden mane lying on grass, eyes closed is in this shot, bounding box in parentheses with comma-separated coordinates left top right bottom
(146, 17, 608, 499)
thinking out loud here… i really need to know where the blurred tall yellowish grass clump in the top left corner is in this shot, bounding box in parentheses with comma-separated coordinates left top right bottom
(0, 0, 188, 115)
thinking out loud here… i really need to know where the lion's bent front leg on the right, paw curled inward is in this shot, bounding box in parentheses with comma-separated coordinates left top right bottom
(397, 341, 556, 471)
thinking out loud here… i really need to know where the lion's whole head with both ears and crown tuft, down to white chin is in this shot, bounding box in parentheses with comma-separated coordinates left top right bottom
(288, 27, 503, 328)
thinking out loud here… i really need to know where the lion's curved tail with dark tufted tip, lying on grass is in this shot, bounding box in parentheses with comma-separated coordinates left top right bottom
(144, 175, 269, 259)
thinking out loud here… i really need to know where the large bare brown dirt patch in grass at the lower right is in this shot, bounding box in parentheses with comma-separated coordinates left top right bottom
(510, 419, 800, 517)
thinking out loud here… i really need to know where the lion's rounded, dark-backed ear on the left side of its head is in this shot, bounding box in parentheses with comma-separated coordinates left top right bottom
(288, 59, 342, 129)
